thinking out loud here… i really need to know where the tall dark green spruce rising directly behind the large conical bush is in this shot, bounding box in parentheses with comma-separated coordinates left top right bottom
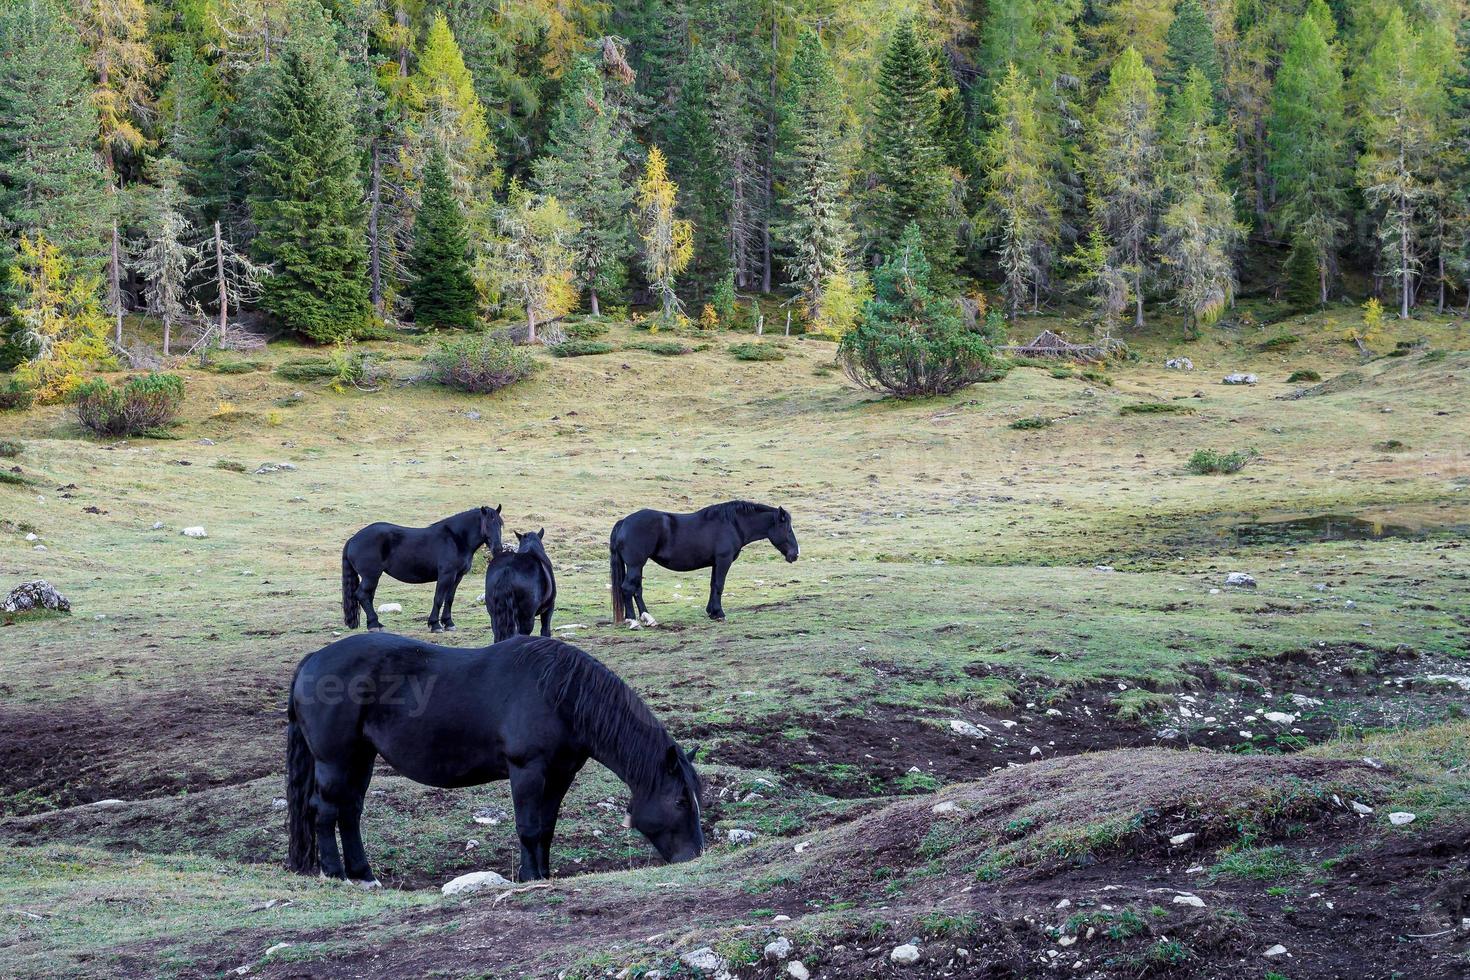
(864, 19, 957, 281)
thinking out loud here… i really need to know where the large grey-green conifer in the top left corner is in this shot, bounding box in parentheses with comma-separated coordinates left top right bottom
(0, 0, 107, 267)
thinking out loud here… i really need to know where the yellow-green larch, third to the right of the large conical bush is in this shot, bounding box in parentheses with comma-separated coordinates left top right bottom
(1158, 68, 1245, 331)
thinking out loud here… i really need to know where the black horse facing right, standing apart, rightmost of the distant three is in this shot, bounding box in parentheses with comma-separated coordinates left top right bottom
(607, 500, 800, 629)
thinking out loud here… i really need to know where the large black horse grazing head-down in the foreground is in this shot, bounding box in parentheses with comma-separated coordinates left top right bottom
(287, 633, 704, 884)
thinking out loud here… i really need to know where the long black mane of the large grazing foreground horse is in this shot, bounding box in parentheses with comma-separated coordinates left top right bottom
(515, 636, 673, 789)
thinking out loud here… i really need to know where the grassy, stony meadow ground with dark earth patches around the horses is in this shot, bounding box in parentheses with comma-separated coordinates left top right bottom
(0, 307, 1470, 980)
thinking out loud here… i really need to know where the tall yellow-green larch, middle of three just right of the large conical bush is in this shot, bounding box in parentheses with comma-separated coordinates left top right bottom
(1088, 47, 1161, 326)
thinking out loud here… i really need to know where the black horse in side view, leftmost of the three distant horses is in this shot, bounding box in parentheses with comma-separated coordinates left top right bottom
(343, 507, 504, 633)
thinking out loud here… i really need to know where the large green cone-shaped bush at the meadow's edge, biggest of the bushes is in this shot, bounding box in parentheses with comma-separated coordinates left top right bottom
(836, 225, 1003, 398)
